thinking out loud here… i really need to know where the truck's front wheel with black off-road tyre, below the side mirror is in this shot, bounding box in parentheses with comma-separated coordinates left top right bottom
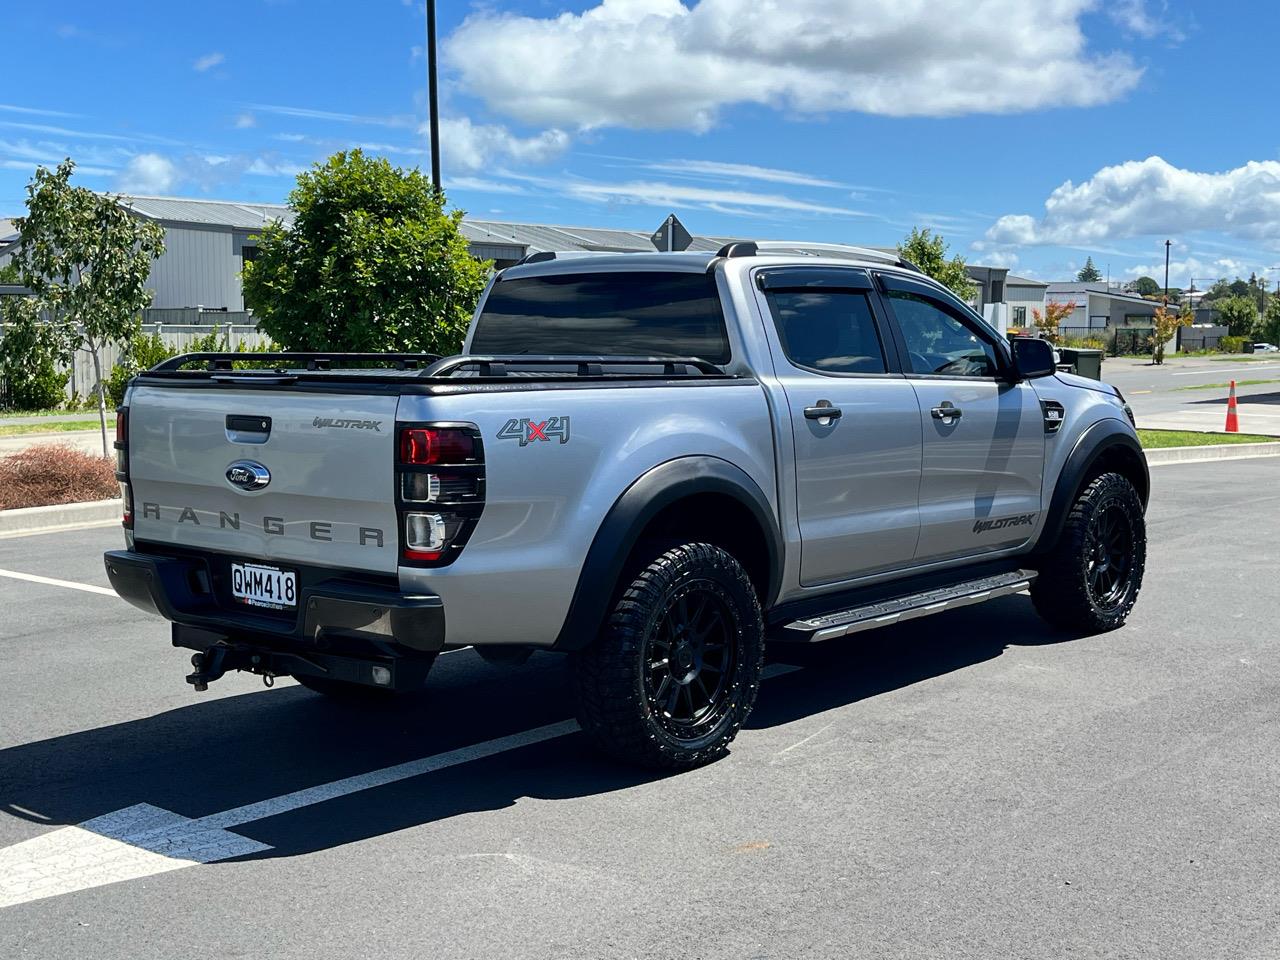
(1032, 474, 1147, 634)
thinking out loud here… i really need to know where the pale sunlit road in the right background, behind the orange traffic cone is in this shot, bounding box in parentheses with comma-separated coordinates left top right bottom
(1102, 355, 1280, 435)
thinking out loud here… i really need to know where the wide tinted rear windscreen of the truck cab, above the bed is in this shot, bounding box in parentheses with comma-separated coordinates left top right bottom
(471, 271, 730, 364)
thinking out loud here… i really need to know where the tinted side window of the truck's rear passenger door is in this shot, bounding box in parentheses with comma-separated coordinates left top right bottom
(769, 289, 887, 374)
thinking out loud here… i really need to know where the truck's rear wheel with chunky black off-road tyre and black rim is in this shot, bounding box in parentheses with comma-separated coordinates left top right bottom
(573, 543, 764, 769)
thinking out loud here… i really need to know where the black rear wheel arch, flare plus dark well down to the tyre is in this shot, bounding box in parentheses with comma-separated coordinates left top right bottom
(553, 457, 782, 650)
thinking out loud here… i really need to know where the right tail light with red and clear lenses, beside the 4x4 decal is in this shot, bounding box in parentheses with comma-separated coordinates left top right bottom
(396, 424, 484, 567)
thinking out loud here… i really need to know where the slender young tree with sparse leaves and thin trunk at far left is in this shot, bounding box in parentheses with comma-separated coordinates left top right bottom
(5, 159, 164, 457)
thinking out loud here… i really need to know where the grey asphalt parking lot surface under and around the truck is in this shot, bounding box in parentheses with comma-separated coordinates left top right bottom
(0, 458, 1280, 960)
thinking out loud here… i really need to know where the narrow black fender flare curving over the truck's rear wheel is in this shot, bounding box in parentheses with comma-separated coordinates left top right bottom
(552, 456, 782, 650)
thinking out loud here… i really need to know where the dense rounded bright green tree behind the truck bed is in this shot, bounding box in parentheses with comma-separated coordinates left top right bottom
(242, 150, 490, 355)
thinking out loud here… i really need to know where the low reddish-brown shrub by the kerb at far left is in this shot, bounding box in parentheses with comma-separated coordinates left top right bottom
(0, 444, 120, 509)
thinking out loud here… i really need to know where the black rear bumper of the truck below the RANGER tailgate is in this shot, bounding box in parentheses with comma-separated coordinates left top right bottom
(102, 550, 444, 657)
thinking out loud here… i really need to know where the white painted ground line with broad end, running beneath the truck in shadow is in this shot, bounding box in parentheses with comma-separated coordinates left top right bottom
(0, 663, 800, 908)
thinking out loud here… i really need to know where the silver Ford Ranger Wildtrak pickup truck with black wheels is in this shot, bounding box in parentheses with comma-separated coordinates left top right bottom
(105, 242, 1148, 767)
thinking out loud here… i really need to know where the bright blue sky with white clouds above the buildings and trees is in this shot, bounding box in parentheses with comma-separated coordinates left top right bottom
(0, 0, 1280, 285)
